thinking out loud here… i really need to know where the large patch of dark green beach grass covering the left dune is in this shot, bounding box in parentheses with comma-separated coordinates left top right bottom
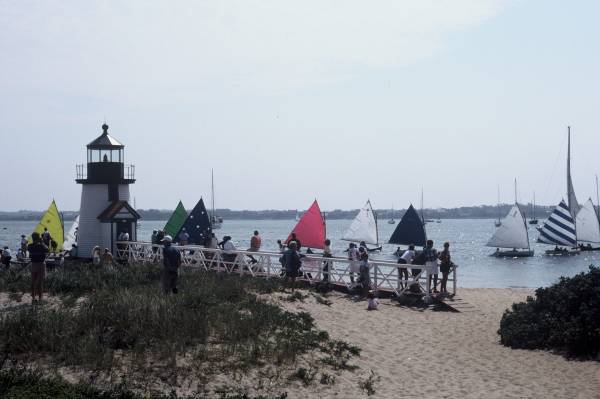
(0, 264, 360, 397)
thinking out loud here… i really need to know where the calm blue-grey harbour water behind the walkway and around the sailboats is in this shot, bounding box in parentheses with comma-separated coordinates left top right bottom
(0, 219, 600, 288)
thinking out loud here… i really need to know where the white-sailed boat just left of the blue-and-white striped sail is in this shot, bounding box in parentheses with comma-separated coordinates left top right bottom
(486, 180, 534, 258)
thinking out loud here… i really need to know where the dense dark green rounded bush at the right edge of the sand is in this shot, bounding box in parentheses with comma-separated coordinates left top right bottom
(498, 266, 600, 358)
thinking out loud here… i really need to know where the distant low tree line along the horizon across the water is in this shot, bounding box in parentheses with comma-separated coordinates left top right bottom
(0, 204, 553, 221)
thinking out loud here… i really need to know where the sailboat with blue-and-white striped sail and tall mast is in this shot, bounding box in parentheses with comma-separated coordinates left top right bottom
(538, 126, 579, 255)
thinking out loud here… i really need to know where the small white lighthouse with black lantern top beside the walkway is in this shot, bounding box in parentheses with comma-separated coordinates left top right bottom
(76, 123, 140, 258)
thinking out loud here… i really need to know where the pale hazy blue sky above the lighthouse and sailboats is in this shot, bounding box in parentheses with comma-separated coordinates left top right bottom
(0, 0, 600, 210)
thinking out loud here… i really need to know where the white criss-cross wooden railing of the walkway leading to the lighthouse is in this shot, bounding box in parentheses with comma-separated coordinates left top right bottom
(117, 241, 457, 296)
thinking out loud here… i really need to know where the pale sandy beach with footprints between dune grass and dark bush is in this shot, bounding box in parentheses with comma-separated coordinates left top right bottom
(276, 289, 600, 398)
